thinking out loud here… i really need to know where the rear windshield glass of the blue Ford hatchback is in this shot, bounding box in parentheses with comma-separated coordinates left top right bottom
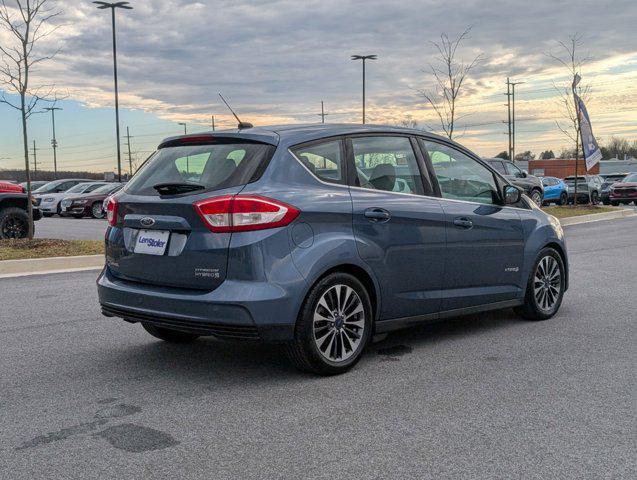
(126, 142, 275, 195)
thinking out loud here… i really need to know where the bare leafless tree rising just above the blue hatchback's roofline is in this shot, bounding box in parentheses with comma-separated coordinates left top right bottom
(420, 27, 484, 139)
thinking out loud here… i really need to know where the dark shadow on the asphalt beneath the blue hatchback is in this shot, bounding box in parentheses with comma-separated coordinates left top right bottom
(99, 310, 520, 385)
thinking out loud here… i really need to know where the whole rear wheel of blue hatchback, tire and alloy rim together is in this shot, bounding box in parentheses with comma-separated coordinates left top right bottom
(287, 273, 372, 375)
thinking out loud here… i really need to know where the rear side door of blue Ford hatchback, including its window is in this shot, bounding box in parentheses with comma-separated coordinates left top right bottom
(347, 135, 445, 320)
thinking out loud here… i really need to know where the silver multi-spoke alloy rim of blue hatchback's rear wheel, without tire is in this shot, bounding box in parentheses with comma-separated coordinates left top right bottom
(313, 284, 365, 362)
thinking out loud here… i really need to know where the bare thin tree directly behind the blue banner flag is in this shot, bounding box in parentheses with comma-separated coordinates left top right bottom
(547, 33, 591, 165)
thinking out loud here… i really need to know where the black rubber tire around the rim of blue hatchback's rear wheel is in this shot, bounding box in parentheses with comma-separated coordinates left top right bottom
(286, 272, 372, 375)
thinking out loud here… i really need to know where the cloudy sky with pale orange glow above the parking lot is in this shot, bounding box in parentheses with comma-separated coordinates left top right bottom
(0, 0, 637, 171)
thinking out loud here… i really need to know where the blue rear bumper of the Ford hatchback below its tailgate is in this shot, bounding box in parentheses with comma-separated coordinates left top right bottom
(97, 268, 298, 342)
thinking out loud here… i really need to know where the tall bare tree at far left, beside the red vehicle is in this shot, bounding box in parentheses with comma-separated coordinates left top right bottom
(0, 0, 61, 239)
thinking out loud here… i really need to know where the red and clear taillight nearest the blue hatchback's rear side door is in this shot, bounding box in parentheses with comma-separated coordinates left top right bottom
(194, 195, 301, 232)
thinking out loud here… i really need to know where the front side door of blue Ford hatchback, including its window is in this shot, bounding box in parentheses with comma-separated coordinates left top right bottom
(421, 140, 525, 310)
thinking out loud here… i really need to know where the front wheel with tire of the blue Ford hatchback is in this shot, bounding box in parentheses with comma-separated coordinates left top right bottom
(515, 248, 566, 320)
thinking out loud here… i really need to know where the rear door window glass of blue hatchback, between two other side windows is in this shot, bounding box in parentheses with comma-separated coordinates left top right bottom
(352, 136, 425, 195)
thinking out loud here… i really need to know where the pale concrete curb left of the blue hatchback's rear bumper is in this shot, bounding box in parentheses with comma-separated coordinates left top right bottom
(0, 255, 104, 279)
